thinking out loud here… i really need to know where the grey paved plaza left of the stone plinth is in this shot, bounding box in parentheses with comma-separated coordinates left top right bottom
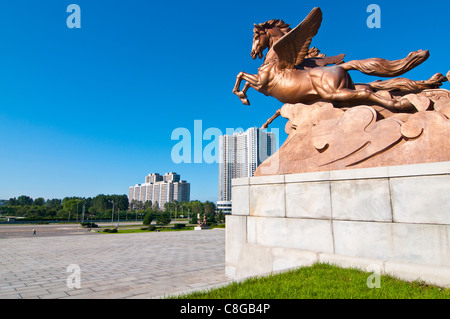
(0, 229, 229, 299)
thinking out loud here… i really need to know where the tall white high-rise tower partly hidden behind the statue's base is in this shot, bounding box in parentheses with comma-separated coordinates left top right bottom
(217, 127, 276, 212)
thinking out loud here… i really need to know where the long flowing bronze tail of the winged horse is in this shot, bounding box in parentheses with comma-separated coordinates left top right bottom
(339, 50, 430, 77)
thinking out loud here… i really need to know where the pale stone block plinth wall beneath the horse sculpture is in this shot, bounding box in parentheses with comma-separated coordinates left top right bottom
(226, 162, 450, 286)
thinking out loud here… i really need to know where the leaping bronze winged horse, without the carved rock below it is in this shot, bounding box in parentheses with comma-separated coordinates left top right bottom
(233, 8, 446, 120)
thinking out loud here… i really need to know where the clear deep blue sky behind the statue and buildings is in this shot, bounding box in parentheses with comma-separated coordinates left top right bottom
(0, 0, 450, 201)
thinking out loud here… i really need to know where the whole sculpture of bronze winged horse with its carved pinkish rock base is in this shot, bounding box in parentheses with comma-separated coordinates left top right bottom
(233, 8, 450, 176)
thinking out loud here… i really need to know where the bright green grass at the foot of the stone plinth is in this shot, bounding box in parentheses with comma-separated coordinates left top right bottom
(177, 264, 450, 299)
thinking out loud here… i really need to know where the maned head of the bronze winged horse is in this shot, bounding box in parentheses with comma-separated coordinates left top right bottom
(251, 19, 291, 60)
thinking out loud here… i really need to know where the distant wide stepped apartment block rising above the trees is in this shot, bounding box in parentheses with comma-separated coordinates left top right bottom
(128, 172, 191, 209)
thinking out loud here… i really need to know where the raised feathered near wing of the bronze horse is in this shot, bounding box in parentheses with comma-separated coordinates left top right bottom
(273, 8, 322, 69)
